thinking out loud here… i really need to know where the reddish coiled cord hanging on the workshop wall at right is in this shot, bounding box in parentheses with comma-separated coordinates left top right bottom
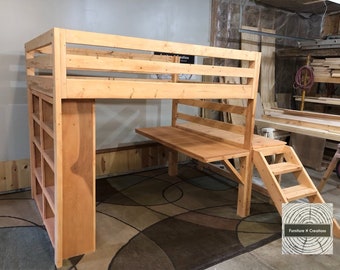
(294, 55, 314, 111)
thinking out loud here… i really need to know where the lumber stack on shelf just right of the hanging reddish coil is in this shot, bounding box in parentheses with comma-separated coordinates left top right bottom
(311, 57, 340, 78)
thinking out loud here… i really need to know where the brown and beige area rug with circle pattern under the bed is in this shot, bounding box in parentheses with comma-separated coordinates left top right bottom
(0, 164, 281, 270)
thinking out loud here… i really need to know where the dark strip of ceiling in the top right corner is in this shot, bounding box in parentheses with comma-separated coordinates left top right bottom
(255, 0, 340, 14)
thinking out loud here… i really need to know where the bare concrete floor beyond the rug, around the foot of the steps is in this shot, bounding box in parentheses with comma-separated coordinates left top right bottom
(207, 169, 340, 270)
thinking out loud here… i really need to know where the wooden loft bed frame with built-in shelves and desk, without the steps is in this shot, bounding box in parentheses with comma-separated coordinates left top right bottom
(25, 28, 338, 267)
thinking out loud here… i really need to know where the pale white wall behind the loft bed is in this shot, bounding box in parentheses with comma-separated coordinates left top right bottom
(0, 0, 211, 161)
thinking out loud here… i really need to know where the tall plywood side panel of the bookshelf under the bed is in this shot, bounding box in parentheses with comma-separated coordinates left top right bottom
(60, 100, 95, 258)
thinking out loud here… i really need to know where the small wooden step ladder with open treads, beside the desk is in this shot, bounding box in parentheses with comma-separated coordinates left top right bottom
(253, 145, 340, 238)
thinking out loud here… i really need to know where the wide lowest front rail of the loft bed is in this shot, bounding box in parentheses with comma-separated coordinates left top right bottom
(62, 78, 253, 99)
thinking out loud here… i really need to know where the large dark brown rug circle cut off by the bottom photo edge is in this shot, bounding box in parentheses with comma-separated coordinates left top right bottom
(109, 214, 242, 270)
